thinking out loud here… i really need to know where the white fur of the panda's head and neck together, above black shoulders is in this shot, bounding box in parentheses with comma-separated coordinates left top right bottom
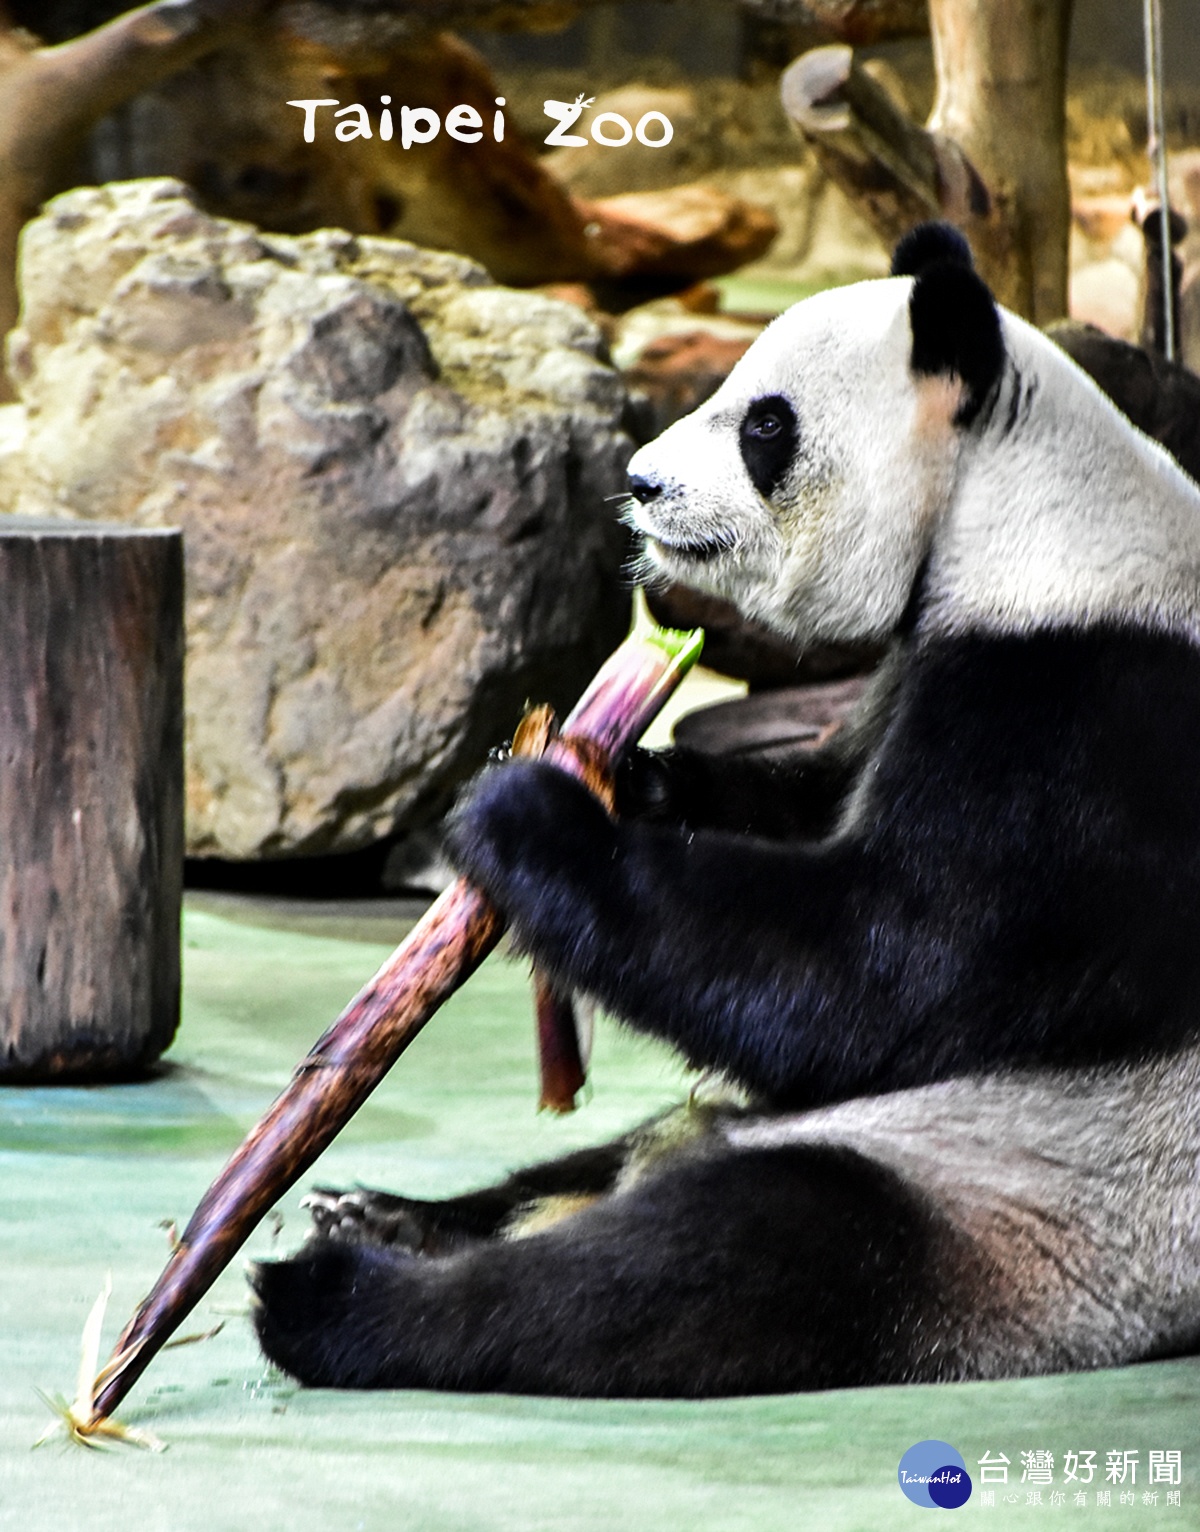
(628, 277, 1200, 645)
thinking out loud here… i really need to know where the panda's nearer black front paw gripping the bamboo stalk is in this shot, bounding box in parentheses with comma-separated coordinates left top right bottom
(446, 760, 616, 930)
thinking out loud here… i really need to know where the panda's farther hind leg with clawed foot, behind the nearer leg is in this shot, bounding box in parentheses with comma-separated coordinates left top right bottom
(302, 1137, 631, 1256)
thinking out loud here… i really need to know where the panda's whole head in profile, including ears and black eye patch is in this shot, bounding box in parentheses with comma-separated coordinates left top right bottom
(628, 224, 1005, 643)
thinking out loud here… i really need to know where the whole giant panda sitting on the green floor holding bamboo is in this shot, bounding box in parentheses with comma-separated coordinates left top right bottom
(253, 225, 1200, 1396)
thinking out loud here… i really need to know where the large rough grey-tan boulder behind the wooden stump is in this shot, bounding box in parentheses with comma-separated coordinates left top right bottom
(0, 181, 630, 858)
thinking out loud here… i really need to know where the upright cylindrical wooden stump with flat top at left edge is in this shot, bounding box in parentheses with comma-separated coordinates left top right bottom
(0, 516, 184, 1082)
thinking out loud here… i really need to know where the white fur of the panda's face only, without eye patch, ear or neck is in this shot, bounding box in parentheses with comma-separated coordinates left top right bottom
(628, 280, 958, 645)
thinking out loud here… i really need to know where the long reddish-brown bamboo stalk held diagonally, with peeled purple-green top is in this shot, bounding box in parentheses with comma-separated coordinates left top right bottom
(91, 609, 702, 1435)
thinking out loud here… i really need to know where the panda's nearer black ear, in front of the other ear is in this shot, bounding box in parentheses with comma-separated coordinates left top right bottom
(893, 224, 1004, 426)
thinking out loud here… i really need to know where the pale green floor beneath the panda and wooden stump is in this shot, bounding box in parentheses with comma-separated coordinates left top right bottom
(0, 896, 1200, 1532)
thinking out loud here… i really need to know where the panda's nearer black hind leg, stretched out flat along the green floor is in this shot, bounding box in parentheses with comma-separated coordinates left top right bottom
(251, 1144, 938, 1397)
